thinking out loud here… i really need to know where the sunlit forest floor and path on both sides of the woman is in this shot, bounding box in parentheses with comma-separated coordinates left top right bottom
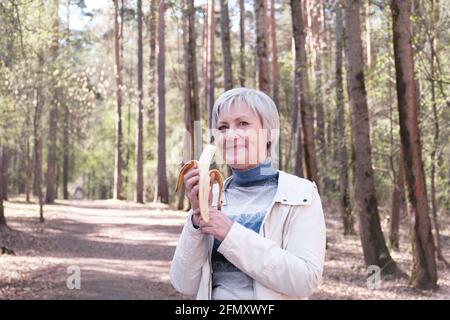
(0, 197, 450, 300)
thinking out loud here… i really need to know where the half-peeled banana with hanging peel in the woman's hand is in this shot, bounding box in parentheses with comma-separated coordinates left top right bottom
(175, 145, 223, 223)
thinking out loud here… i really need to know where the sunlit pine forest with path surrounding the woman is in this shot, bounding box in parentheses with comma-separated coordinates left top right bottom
(0, 0, 450, 299)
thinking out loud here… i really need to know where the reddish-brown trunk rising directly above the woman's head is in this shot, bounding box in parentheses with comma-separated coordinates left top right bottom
(255, 0, 270, 94)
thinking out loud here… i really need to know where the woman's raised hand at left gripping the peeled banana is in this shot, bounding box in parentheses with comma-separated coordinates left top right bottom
(184, 164, 215, 226)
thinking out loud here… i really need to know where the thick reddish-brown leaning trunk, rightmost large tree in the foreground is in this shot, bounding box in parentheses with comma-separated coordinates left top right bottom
(391, 0, 437, 289)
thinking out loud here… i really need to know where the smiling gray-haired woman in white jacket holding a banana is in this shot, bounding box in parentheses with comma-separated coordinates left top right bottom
(170, 88, 325, 300)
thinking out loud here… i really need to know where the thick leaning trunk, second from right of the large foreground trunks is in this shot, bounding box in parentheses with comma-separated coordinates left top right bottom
(344, 0, 399, 274)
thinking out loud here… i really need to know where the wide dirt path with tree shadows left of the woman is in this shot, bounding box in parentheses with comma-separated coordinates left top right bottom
(0, 200, 191, 299)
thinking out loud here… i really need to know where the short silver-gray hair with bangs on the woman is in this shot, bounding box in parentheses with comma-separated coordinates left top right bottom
(211, 88, 280, 163)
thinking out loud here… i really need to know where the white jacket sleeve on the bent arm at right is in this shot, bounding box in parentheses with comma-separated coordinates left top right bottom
(218, 186, 326, 298)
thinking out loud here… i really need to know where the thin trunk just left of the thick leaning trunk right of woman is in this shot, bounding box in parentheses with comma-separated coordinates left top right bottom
(336, 3, 355, 235)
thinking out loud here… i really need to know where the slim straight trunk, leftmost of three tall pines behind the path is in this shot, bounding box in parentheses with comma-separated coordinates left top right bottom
(113, 0, 123, 199)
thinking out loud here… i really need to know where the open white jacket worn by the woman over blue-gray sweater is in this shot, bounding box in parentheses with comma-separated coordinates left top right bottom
(170, 171, 326, 300)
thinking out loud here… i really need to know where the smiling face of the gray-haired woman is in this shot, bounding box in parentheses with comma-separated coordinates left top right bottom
(215, 104, 268, 170)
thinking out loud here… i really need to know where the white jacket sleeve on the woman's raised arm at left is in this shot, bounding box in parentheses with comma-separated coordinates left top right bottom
(170, 210, 208, 295)
